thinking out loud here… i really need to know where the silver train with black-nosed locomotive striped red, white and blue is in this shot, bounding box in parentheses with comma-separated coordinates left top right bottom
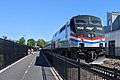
(45, 15, 105, 62)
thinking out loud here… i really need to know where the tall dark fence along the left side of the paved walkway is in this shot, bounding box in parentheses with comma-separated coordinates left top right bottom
(0, 39, 30, 69)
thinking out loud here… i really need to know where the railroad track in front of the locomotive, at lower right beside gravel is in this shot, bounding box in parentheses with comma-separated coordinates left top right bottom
(81, 64, 120, 80)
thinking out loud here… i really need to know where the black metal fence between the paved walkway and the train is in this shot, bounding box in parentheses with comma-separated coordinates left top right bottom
(43, 50, 120, 80)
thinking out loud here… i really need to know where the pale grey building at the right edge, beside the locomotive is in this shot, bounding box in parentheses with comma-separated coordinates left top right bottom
(104, 12, 120, 59)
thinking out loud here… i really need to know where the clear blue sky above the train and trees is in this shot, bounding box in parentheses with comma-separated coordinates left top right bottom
(0, 0, 120, 41)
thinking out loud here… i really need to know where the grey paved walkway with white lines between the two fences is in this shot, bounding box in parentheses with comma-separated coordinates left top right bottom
(0, 52, 62, 80)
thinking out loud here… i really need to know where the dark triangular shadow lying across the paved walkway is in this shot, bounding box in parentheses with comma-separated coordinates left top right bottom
(35, 53, 52, 67)
